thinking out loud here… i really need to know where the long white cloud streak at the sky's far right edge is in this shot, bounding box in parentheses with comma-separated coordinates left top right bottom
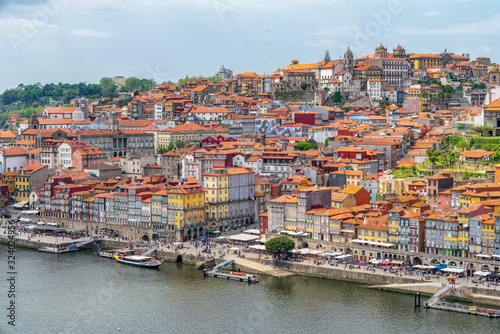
(398, 14, 500, 36)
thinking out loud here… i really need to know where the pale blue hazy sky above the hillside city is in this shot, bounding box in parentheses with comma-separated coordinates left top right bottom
(0, 0, 500, 92)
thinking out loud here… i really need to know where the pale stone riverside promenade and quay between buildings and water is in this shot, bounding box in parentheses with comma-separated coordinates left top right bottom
(0, 228, 500, 306)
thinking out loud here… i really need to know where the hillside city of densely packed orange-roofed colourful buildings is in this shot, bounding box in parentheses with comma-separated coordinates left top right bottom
(0, 44, 500, 257)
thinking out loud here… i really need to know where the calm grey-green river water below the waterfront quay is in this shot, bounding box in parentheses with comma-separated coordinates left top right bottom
(0, 245, 500, 334)
